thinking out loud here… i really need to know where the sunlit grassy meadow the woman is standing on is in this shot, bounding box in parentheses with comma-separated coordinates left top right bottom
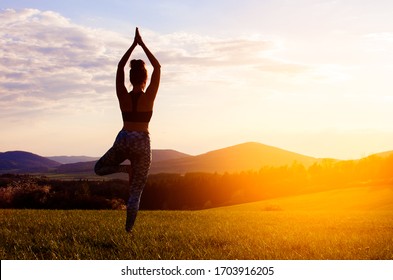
(0, 187, 393, 260)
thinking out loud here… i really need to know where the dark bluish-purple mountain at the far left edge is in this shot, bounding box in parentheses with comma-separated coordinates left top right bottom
(0, 151, 61, 173)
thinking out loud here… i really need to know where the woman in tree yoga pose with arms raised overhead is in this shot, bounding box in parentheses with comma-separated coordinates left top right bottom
(94, 28, 161, 232)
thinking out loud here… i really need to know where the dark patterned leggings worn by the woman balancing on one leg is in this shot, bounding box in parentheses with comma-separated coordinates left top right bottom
(94, 130, 151, 231)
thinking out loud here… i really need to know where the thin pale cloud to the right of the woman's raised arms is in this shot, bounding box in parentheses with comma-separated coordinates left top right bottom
(152, 33, 312, 85)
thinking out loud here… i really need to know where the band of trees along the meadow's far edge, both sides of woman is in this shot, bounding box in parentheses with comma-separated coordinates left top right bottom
(0, 155, 393, 210)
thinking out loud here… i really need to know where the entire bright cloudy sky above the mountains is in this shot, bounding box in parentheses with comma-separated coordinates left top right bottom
(0, 0, 393, 159)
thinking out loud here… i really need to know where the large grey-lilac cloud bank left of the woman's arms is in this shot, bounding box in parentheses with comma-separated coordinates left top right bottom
(0, 9, 124, 120)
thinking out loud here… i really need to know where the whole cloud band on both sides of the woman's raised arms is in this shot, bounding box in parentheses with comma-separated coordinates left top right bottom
(0, 9, 316, 123)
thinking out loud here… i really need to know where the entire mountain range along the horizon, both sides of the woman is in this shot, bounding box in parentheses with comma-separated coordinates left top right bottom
(0, 142, 393, 175)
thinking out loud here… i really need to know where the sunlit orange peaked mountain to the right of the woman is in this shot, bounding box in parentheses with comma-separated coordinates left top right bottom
(151, 142, 318, 173)
